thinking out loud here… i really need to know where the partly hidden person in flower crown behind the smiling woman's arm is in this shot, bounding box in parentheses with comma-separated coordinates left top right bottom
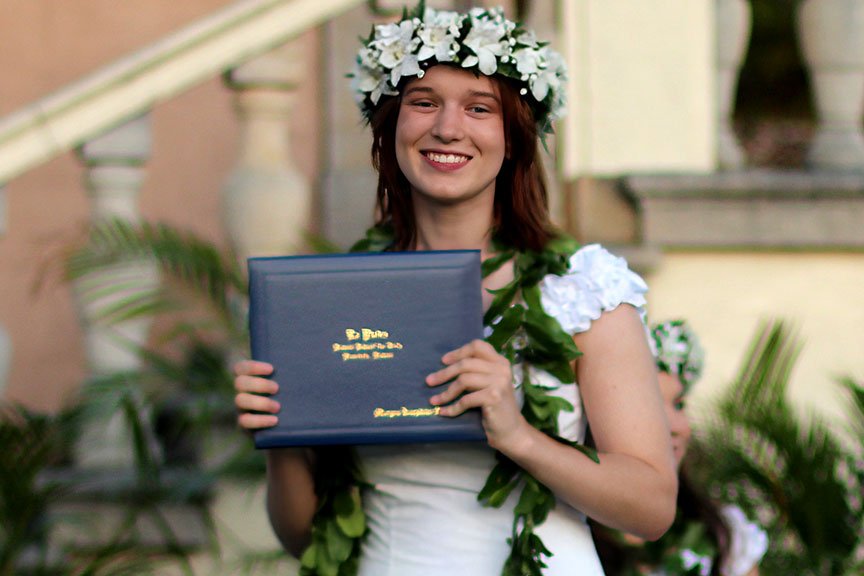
(594, 320, 768, 576)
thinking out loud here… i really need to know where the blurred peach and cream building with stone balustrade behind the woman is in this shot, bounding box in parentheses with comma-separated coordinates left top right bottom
(0, 0, 864, 572)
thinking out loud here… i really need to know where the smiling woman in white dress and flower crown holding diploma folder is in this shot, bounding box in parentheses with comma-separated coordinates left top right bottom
(235, 4, 676, 576)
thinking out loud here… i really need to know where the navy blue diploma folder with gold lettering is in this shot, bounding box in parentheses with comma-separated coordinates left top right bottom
(248, 250, 485, 448)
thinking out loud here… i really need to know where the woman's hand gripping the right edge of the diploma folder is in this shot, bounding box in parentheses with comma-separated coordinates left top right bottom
(426, 340, 530, 453)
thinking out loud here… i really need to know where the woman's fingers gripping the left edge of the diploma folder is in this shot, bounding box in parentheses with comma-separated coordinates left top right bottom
(234, 360, 280, 430)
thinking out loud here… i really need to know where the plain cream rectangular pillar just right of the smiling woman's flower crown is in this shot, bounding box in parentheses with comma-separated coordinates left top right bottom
(558, 0, 717, 180)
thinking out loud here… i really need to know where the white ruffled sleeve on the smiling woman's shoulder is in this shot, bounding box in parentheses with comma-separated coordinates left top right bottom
(540, 244, 648, 334)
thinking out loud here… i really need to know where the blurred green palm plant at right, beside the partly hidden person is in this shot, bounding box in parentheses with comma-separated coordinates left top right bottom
(691, 321, 864, 576)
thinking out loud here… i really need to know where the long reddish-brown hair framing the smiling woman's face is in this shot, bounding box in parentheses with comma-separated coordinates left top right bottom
(370, 67, 554, 251)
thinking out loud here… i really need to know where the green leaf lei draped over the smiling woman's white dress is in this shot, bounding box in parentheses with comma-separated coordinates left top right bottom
(300, 227, 599, 576)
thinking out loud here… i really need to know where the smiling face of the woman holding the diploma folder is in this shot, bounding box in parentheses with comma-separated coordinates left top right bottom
(396, 66, 506, 207)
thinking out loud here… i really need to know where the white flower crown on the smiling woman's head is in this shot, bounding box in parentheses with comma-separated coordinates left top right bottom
(349, 1, 567, 135)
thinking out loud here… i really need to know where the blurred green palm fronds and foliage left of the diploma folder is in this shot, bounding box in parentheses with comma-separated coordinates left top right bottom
(0, 219, 284, 576)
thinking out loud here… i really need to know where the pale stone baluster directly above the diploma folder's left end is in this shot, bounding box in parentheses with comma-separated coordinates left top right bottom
(222, 39, 314, 258)
